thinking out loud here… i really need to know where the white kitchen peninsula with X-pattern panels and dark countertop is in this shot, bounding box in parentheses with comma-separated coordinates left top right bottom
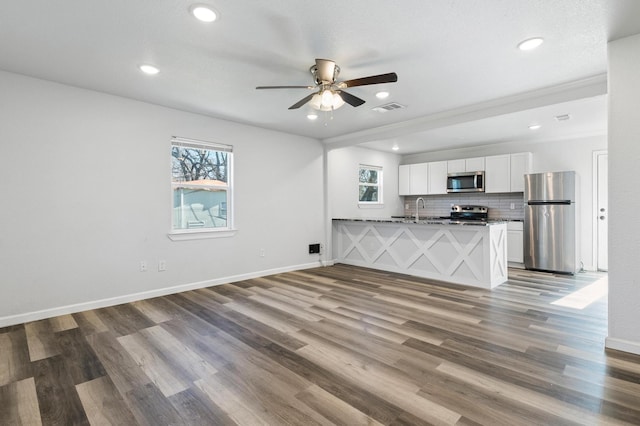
(333, 218, 507, 289)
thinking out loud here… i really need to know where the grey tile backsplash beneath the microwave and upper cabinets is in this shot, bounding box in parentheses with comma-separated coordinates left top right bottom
(404, 192, 524, 220)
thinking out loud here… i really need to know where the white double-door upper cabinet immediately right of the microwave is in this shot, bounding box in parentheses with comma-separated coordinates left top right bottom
(484, 152, 532, 192)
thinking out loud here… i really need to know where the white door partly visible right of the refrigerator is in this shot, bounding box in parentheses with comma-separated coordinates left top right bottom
(593, 151, 609, 271)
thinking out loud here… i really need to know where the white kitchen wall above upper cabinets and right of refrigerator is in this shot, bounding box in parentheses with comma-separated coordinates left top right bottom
(402, 135, 607, 270)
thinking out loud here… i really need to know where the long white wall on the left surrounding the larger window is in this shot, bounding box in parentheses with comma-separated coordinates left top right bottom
(0, 72, 326, 326)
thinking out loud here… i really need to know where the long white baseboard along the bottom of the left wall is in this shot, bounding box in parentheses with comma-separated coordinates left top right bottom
(0, 261, 324, 327)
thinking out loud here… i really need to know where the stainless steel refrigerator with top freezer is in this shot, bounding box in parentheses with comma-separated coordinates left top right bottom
(524, 172, 577, 274)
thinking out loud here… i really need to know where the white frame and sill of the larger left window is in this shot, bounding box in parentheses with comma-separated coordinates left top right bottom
(167, 136, 236, 241)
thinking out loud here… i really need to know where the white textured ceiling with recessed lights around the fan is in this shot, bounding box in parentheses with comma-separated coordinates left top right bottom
(0, 0, 640, 153)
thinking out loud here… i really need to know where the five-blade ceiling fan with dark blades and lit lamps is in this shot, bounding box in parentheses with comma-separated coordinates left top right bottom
(256, 59, 398, 111)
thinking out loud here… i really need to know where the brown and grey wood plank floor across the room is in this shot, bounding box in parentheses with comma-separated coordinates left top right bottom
(0, 265, 640, 425)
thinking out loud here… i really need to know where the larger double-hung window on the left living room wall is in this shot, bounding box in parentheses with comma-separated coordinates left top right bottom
(171, 138, 233, 233)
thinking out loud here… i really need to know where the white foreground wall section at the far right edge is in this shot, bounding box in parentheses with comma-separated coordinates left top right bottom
(607, 34, 640, 354)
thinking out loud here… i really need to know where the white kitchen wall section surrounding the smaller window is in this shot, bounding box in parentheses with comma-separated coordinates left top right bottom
(327, 147, 404, 219)
